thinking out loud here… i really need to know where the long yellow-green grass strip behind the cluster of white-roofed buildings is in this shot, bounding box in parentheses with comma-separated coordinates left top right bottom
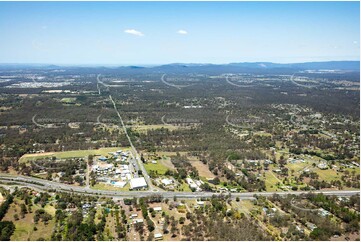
(19, 147, 129, 163)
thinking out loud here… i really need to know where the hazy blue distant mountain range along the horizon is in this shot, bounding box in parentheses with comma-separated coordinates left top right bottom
(0, 61, 360, 72)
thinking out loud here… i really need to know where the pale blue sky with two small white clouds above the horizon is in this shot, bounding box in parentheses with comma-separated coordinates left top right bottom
(0, 2, 360, 65)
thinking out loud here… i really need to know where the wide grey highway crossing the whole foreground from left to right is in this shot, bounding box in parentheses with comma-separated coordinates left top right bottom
(0, 173, 360, 199)
